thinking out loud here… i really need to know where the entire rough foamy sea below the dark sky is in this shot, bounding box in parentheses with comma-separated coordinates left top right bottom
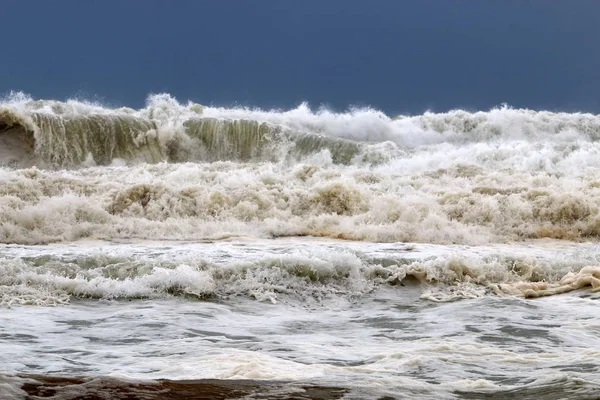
(0, 93, 600, 399)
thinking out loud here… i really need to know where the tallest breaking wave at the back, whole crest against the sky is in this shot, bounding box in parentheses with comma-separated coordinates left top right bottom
(0, 93, 600, 168)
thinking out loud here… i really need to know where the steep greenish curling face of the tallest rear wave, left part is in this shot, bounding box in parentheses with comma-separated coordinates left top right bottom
(0, 95, 364, 169)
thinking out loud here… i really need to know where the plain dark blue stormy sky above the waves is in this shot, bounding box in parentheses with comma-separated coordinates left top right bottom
(0, 0, 600, 114)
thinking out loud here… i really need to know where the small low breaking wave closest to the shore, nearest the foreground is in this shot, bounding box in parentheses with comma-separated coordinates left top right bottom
(0, 242, 600, 306)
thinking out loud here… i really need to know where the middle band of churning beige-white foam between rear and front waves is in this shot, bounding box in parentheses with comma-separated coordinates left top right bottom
(0, 145, 600, 244)
